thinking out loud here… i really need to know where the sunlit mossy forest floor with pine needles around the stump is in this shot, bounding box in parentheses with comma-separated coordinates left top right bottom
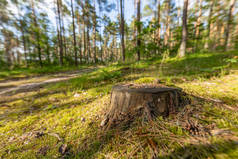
(0, 52, 238, 159)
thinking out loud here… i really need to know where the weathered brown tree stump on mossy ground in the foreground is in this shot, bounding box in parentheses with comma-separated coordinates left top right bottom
(101, 85, 189, 128)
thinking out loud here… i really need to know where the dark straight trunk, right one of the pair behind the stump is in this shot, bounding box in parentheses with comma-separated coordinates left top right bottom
(137, 0, 141, 61)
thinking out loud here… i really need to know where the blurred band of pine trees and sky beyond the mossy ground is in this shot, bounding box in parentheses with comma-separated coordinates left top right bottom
(0, 0, 238, 68)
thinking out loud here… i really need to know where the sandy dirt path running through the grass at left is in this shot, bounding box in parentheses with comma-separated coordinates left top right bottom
(0, 68, 95, 97)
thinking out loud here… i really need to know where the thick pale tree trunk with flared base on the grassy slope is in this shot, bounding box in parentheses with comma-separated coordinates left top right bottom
(178, 0, 188, 57)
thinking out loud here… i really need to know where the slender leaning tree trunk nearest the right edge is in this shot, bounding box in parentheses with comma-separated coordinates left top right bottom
(224, 0, 236, 51)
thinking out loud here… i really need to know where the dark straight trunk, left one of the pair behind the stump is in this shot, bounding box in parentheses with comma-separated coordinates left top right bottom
(120, 0, 126, 62)
